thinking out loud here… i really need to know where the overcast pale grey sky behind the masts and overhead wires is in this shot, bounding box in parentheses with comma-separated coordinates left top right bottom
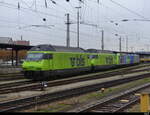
(0, 0, 150, 51)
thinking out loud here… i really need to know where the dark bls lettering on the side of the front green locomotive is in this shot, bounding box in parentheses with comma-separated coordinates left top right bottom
(70, 56, 85, 67)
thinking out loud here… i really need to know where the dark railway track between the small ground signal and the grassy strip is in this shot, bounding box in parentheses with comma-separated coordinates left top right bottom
(0, 70, 150, 112)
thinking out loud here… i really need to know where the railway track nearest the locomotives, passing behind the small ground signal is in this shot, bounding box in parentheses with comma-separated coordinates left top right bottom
(0, 63, 150, 94)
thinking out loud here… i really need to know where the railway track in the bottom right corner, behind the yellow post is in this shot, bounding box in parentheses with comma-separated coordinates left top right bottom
(72, 83, 146, 112)
